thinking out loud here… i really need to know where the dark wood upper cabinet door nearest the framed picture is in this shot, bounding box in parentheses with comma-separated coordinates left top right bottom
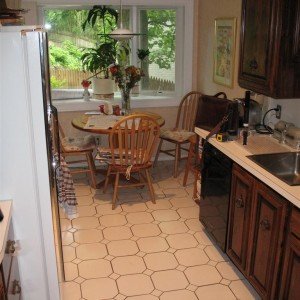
(239, 0, 279, 95)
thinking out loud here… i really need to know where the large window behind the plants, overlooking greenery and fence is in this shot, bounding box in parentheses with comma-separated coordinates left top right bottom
(41, 0, 193, 103)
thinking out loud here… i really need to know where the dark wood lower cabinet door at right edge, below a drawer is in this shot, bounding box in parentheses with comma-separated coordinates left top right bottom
(280, 234, 300, 300)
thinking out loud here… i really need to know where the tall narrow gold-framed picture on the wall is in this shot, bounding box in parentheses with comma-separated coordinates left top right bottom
(213, 18, 236, 88)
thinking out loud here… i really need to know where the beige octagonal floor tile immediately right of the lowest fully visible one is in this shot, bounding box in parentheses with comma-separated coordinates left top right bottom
(151, 270, 189, 291)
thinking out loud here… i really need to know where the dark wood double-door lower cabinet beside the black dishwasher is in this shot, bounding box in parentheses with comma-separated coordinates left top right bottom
(226, 164, 290, 300)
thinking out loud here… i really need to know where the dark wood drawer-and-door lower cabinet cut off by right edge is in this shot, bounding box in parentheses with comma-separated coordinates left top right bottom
(279, 209, 300, 300)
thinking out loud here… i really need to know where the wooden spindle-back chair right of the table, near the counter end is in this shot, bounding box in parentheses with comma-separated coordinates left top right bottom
(154, 91, 202, 178)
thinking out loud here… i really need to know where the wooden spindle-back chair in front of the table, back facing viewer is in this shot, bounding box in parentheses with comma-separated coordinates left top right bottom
(99, 114, 160, 209)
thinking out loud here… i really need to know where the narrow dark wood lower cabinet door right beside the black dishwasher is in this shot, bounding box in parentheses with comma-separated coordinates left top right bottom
(227, 164, 253, 272)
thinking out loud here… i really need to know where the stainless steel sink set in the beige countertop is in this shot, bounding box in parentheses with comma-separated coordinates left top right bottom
(248, 152, 300, 185)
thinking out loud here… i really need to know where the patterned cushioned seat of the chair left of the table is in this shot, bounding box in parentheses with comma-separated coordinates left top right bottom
(61, 135, 96, 152)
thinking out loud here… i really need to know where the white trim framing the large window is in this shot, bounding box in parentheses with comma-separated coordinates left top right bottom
(38, 0, 194, 111)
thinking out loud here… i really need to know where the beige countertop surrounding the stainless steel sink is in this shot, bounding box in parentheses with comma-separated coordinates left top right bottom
(195, 128, 300, 208)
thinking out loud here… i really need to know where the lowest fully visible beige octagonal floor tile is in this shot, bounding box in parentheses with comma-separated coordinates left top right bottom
(117, 274, 154, 296)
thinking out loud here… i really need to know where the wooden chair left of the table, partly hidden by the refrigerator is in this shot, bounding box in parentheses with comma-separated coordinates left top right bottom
(58, 124, 97, 188)
